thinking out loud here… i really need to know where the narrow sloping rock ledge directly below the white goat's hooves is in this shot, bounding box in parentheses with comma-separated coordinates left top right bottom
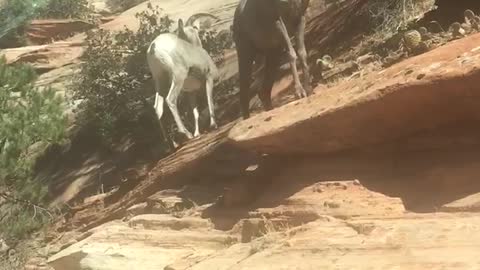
(64, 124, 243, 230)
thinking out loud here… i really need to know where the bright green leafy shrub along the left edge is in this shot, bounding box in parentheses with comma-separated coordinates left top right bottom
(0, 58, 66, 242)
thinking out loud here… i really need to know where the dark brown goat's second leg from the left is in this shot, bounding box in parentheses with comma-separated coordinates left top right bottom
(258, 50, 281, 111)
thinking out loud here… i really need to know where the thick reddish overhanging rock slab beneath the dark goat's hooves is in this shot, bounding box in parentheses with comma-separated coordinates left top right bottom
(229, 34, 480, 154)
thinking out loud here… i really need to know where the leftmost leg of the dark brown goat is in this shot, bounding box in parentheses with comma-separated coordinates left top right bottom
(236, 40, 255, 119)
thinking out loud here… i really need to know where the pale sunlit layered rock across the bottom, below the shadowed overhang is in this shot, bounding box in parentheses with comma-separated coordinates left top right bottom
(49, 177, 480, 270)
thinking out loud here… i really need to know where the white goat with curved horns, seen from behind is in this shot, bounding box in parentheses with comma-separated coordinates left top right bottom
(147, 13, 218, 147)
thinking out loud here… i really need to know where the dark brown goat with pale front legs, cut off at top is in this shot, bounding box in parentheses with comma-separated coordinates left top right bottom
(233, 0, 312, 119)
